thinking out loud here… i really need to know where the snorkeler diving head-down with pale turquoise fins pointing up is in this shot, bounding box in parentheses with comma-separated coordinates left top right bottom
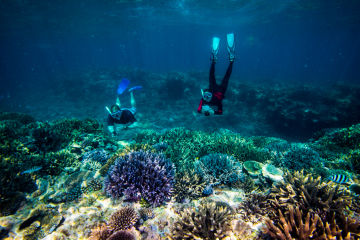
(197, 33, 235, 116)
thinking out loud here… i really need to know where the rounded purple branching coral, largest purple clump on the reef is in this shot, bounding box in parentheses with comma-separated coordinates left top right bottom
(105, 151, 175, 206)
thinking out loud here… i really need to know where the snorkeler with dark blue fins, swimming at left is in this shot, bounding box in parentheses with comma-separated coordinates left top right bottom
(106, 79, 142, 136)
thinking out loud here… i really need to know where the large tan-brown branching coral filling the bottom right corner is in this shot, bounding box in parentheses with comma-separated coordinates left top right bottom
(267, 172, 360, 239)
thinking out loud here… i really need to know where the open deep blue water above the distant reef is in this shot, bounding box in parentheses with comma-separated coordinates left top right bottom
(0, 0, 360, 96)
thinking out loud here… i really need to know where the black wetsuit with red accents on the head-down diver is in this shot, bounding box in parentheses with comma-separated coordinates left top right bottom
(197, 61, 234, 115)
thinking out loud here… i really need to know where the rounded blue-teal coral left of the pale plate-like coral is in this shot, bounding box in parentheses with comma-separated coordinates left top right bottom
(194, 154, 242, 185)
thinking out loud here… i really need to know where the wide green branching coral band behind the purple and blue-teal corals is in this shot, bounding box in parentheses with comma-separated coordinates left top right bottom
(135, 128, 271, 169)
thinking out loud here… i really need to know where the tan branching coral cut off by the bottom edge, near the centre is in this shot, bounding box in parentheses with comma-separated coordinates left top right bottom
(171, 202, 232, 240)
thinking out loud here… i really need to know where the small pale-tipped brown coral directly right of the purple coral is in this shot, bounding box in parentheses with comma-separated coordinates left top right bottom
(174, 170, 206, 202)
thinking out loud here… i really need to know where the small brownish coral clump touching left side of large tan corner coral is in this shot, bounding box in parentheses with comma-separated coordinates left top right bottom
(236, 193, 270, 223)
